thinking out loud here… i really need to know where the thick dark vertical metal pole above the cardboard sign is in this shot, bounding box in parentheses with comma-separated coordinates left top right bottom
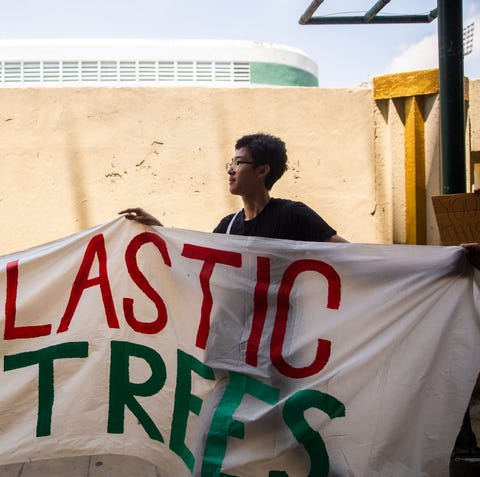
(438, 0, 466, 194)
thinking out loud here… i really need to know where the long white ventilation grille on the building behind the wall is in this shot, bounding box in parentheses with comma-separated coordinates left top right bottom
(0, 60, 250, 86)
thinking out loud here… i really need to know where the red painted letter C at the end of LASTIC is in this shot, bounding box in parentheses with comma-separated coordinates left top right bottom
(270, 259, 341, 378)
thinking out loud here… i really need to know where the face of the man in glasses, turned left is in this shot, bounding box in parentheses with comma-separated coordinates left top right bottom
(227, 147, 263, 195)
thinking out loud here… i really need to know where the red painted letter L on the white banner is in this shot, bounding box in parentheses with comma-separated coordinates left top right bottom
(3, 260, 52, 340)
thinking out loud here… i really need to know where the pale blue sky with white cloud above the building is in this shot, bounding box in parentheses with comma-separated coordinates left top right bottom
(0, 0, 480, 88)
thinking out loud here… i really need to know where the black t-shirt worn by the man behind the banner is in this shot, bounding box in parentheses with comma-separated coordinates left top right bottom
(213, 199, 337, 242)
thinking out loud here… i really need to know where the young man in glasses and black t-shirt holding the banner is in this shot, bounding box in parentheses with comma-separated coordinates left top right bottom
(120, 134, 346, 242)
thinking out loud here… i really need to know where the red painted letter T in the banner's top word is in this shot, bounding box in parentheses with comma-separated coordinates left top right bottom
(182, 244, 242, 349)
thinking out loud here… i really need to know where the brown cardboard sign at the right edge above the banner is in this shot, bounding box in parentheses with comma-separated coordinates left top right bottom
(432, 194, 480, 245)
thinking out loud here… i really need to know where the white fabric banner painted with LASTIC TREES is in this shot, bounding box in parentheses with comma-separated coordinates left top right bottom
(0, 218, 480, 477)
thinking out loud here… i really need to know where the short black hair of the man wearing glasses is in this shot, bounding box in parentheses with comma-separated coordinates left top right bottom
(235, 133, 288, 190)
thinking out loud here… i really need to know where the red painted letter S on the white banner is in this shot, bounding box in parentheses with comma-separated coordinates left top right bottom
(123, 232, 172, 334)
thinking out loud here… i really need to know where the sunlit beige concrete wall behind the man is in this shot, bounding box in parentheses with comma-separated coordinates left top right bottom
(0, 88, 384, 254)
